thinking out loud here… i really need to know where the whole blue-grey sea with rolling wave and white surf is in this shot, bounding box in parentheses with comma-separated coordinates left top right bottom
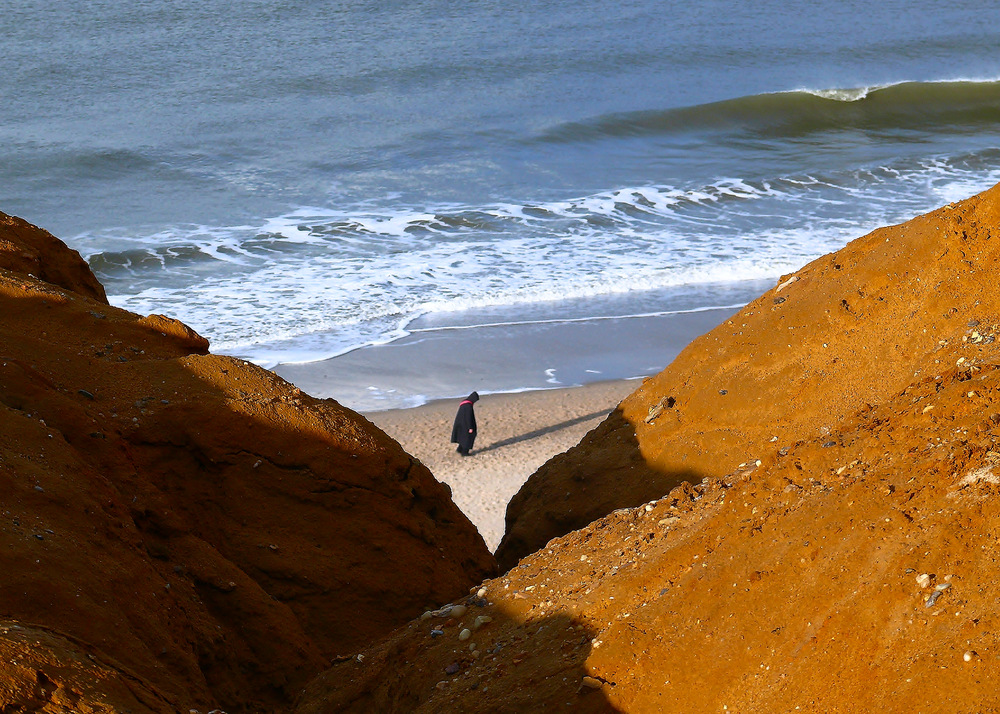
(0, 0, 1000, 406)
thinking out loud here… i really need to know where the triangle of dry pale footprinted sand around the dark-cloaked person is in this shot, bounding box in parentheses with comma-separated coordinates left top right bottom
(365, 380, 641, 550)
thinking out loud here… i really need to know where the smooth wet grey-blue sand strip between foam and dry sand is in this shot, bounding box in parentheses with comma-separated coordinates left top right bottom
(272, 300, 739, 413)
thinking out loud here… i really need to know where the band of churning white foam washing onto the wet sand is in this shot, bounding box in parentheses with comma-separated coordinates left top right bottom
(95, 157, 1000, 365)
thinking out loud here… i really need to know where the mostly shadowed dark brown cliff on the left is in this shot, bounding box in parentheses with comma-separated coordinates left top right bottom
(0, 214, 495, 714)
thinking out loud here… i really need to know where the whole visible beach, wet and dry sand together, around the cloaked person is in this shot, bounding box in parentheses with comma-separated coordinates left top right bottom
(273, 294, 746, 551)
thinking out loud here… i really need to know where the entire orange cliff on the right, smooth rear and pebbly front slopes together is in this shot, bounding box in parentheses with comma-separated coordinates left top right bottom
(297, 189, 1000, 714)
